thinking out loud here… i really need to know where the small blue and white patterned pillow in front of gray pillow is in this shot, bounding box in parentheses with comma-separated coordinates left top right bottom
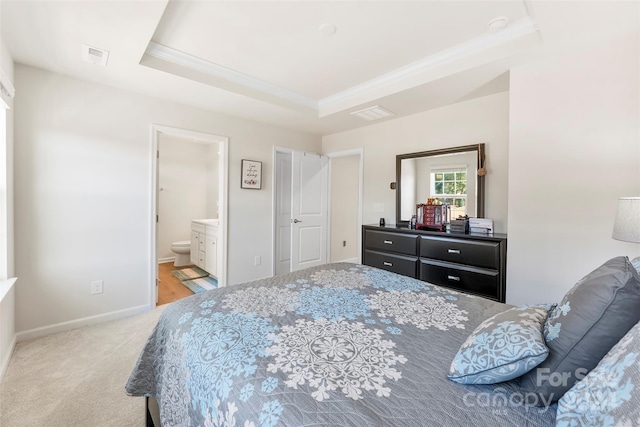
(448, 306, 549, 384)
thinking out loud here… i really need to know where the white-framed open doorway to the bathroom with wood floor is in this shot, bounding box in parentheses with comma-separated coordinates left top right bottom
(150, 126, 228, 307)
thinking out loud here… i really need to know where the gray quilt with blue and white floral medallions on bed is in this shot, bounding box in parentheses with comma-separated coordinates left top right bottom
(126, 263, 555, 427)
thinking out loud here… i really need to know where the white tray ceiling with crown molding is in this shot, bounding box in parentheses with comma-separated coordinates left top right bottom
(0, 0, 640, 135)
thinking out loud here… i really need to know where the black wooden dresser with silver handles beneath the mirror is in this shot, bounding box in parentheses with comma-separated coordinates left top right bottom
(362, 225, 507, 302)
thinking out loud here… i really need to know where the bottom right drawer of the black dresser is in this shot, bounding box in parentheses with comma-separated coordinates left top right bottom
(419, 260, 504, 302)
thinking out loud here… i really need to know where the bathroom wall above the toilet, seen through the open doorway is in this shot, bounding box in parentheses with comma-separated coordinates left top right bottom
(157, 134, 218, 260)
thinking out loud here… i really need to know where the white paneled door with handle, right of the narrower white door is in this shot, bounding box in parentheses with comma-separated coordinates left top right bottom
(291, 151, 329, 271)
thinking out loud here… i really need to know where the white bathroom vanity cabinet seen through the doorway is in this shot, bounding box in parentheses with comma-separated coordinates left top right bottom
(191, 219, 218, 277)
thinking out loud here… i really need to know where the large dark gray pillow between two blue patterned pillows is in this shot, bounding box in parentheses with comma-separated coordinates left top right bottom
(519, 257, 640, 406)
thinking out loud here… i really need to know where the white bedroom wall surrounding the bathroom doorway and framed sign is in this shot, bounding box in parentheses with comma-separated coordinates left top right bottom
(15, 65, 321, 337)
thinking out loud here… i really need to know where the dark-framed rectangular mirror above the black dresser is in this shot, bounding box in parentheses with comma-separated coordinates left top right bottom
(396, 144, 486, 224)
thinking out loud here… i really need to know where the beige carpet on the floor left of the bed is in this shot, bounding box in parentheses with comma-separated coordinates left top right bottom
(0, 306, 166, 427)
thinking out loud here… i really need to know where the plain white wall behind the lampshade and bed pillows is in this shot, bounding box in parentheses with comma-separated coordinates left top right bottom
(504, 34, 640, 304)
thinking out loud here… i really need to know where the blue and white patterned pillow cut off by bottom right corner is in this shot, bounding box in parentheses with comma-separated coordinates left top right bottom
(556, 323, 640, 427)
